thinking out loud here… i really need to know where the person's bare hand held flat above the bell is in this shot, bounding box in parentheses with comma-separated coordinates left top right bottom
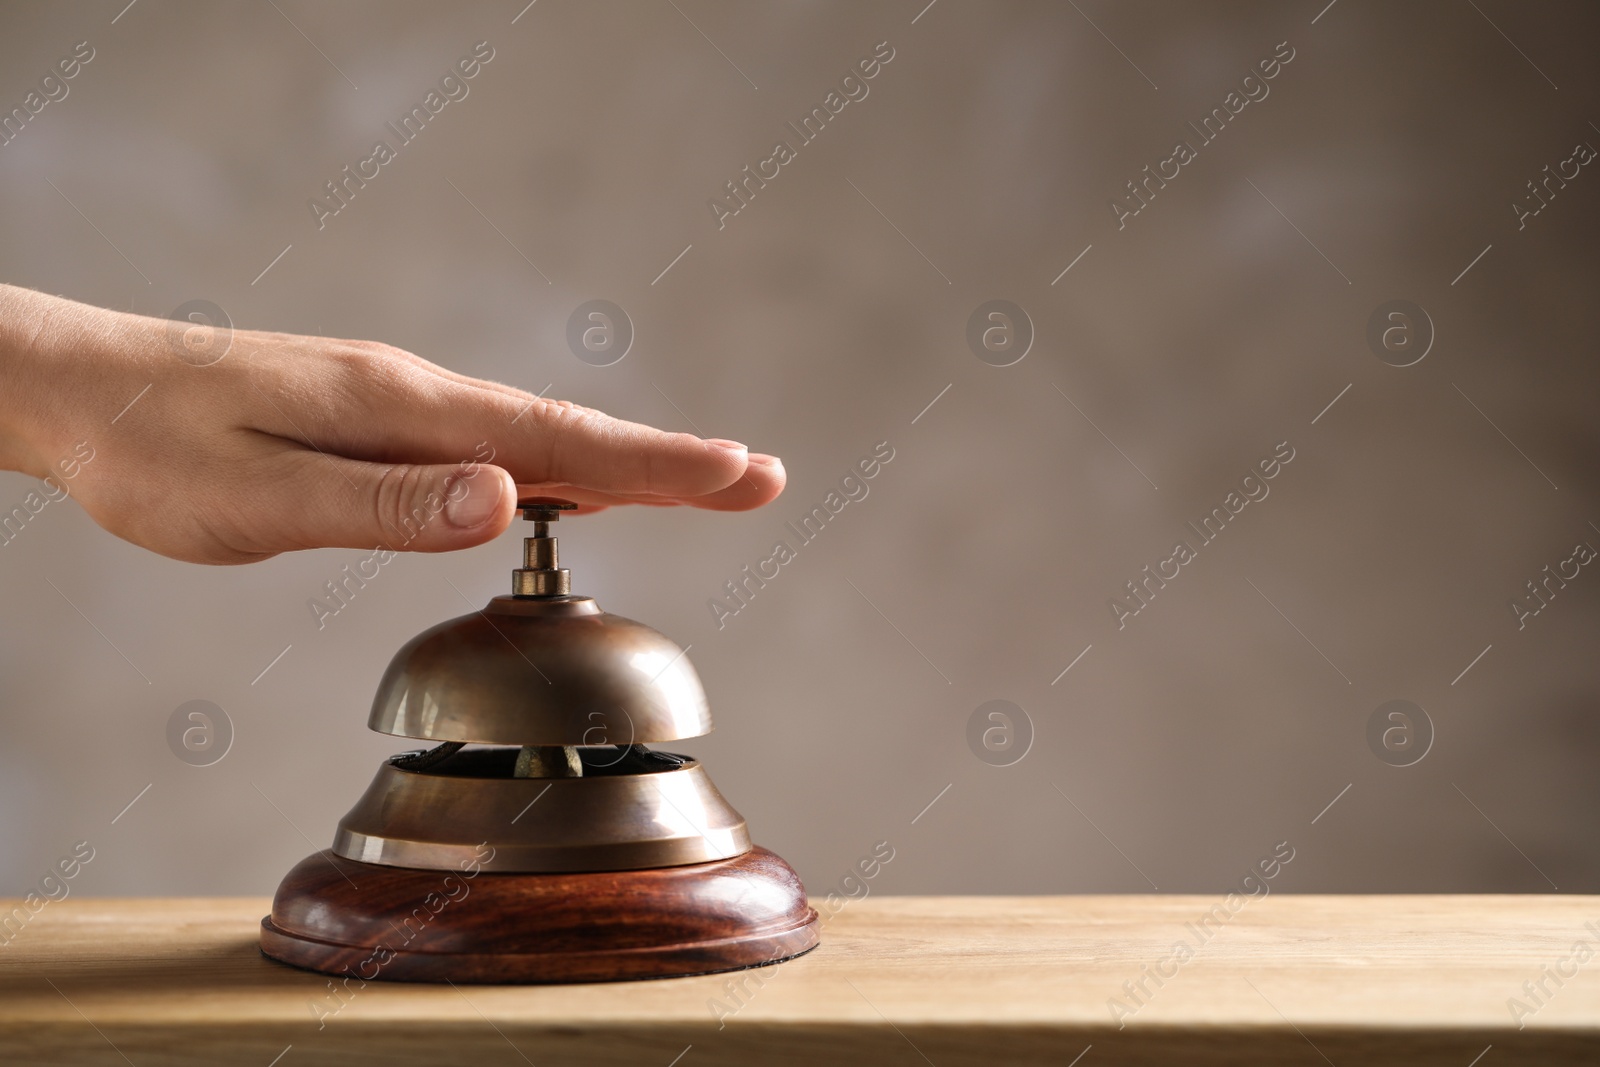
(0, 285, 784, 563)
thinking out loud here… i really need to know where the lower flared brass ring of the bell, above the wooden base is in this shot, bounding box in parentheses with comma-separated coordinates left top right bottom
(333, 747, 750, 872)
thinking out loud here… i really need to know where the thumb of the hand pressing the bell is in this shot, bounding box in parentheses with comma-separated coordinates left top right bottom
(270, 451, 517, 552)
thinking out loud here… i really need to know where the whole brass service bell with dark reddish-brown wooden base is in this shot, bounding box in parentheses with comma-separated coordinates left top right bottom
(261, 496, 818, 982)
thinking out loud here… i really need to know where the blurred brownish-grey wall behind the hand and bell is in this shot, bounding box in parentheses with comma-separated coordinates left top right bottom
(0, 0, 1600, 894)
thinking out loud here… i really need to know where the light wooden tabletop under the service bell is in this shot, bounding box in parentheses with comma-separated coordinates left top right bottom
(0, 894, 1600, 1067)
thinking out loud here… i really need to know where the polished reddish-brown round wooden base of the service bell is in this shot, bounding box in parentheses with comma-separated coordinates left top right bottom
(261, 848, 818, 982)
